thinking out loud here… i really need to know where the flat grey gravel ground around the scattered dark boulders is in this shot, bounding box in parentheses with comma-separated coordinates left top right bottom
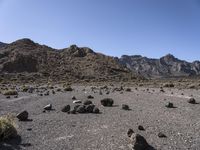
(0, 86, 200, 150)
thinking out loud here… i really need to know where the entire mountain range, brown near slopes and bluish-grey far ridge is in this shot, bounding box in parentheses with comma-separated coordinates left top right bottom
(0, 39, 200, 82)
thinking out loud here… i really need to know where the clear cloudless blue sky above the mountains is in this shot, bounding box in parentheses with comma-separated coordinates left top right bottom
(0, 0, 200, 61)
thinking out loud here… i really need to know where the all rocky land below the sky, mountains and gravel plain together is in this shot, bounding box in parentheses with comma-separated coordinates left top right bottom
(0, 39, 200, 150)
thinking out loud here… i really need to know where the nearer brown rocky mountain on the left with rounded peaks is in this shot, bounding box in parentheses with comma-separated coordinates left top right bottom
(0, 39, 140, 82)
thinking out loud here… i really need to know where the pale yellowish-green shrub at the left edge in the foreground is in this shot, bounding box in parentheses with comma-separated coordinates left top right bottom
(0, 115, 17, 141)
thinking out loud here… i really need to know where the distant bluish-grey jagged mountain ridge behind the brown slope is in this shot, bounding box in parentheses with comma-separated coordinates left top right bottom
(119, 54, 200, 78)
